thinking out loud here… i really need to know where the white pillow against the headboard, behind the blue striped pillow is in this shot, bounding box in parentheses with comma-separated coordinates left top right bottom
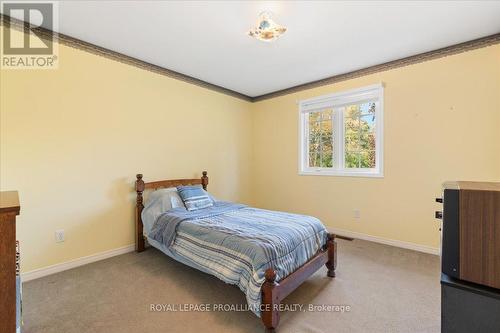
(141, 187, 186, 236)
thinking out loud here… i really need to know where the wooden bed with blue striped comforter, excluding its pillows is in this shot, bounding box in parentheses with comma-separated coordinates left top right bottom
(135, 171, 337, 332)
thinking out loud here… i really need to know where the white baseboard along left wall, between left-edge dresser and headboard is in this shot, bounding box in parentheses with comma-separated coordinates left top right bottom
(21, 244, 135, 282)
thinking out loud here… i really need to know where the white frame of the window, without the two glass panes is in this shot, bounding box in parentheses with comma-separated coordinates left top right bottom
(299, 83, 384, 177)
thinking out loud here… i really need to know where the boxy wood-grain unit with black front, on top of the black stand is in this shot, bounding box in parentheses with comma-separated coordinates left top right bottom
(438, 182, 500, 289)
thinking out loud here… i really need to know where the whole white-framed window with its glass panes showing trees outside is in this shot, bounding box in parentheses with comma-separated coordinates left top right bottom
(299, 84, 383, 177)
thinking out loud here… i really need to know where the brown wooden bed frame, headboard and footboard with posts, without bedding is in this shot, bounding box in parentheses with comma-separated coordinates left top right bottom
(135, 171, 337, 333)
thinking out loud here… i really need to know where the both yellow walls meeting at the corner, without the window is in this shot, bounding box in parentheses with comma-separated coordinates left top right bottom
(0, 24, 500, 272)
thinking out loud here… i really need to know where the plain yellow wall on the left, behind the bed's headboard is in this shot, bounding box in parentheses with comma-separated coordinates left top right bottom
(0, 29, 251, 272)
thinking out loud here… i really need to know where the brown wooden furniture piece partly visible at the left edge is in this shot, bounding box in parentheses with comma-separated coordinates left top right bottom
(0, 191, 20, 333)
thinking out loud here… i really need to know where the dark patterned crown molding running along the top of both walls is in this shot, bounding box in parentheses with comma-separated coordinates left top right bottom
(0, 13, 500, 102)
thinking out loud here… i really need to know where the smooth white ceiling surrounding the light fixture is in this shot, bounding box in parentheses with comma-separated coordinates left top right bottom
(3, 1, 500, 97)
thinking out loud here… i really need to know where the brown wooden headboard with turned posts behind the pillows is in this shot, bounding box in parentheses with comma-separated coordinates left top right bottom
(135, 171, 208, 252)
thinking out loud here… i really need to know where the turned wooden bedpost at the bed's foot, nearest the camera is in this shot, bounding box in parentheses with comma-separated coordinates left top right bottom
(260, 268, 280, 333)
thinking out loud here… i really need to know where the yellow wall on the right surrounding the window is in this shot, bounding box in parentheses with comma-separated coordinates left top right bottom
(252, 45, 500, 248)
